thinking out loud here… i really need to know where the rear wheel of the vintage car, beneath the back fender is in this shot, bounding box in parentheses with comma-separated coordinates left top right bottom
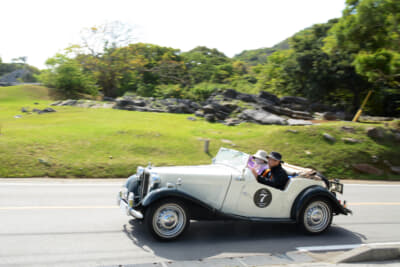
(297, 198, 333, 235)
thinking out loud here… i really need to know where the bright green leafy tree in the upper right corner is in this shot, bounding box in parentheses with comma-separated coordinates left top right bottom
(324, 0, 400, 115)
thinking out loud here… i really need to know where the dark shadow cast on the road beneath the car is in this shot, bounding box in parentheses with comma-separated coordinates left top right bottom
(124, 220, 365, 261)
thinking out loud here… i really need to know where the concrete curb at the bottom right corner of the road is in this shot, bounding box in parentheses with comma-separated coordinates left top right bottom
(333, 244, 400, 263)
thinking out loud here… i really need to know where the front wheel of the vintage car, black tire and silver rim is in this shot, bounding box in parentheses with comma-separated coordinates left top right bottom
(144, 199, 190, 241)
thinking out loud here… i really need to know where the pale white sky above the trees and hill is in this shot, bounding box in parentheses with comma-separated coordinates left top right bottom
(0, 0, 345, 69)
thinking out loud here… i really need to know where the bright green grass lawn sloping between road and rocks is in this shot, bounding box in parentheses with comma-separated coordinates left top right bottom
(0, 86, 400, 180)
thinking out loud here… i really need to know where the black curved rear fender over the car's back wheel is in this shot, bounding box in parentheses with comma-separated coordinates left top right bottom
(290, 186, 351, 221)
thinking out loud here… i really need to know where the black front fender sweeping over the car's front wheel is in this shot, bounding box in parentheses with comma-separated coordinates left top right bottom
(142, 188, 217, 219)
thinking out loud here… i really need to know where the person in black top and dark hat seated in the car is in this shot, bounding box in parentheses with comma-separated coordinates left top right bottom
(250, 152, 289, 190)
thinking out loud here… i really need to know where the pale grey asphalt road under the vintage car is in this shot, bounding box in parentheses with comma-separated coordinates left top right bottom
(0, 179, 400, 266)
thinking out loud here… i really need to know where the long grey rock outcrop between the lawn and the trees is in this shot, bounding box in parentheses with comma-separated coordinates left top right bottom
(52, 89, 360, 126)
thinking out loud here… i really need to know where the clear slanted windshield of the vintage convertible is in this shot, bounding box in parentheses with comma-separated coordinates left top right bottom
(213, 147, 250, 170)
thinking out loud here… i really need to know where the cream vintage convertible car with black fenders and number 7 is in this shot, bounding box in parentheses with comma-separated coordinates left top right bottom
(117, 148, 351, 240)
